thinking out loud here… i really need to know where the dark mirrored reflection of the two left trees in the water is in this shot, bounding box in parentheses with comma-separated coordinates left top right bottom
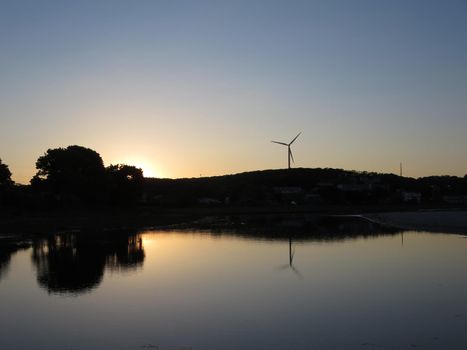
(32, 232, 145, 294)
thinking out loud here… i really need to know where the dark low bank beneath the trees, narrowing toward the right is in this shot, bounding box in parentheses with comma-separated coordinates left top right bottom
(0, 205, 388, 235)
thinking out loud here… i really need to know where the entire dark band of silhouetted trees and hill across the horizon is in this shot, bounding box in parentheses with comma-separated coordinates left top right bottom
(0, 146, 467, 209)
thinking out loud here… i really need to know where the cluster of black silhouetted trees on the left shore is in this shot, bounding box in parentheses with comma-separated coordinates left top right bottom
(0, 146, 144, 208)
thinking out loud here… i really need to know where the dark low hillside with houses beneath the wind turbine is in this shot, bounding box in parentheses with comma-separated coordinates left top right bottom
(144, 168, 467, 205)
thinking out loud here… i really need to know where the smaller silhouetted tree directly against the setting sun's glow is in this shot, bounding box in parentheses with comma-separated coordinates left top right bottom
(105, 164, 144, 204)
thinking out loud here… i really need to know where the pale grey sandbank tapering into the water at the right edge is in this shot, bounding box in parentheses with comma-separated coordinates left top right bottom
(362, 209, 467, 234)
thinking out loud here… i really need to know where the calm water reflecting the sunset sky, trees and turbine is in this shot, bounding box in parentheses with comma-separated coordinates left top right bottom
(0, 221, 467, 350)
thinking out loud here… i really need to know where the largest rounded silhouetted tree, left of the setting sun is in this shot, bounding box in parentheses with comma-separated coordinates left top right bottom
(31, 146, 105, 199)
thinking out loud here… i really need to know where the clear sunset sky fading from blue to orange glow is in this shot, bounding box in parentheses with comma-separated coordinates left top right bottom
(0, 0, 467, 183)
